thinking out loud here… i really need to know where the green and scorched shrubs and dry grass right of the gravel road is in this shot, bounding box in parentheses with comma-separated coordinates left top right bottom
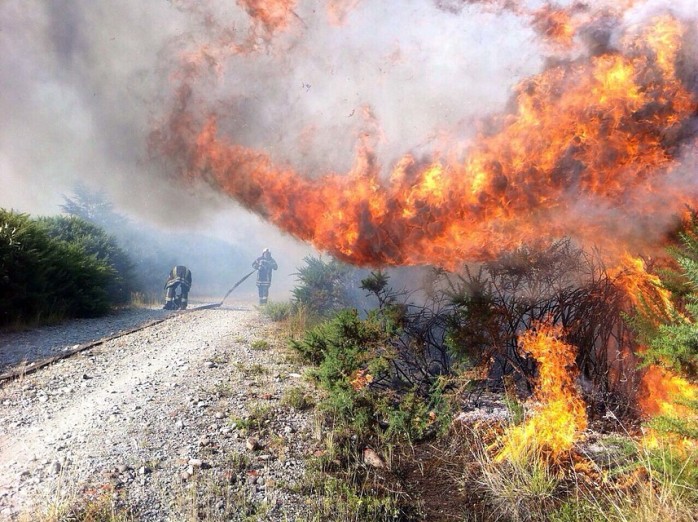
(280, 237, 698, 521)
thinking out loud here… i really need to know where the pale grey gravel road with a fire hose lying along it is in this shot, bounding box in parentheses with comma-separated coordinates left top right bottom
(0, 302, 319, 521)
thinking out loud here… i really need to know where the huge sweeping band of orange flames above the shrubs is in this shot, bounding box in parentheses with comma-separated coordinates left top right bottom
(154, 13, 698, 268)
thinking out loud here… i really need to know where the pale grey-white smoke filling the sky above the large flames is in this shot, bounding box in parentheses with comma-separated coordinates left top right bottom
(0, 0, 695, 282)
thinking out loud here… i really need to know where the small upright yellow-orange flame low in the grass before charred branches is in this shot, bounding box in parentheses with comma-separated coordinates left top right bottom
(498, 325, 587, 460)
